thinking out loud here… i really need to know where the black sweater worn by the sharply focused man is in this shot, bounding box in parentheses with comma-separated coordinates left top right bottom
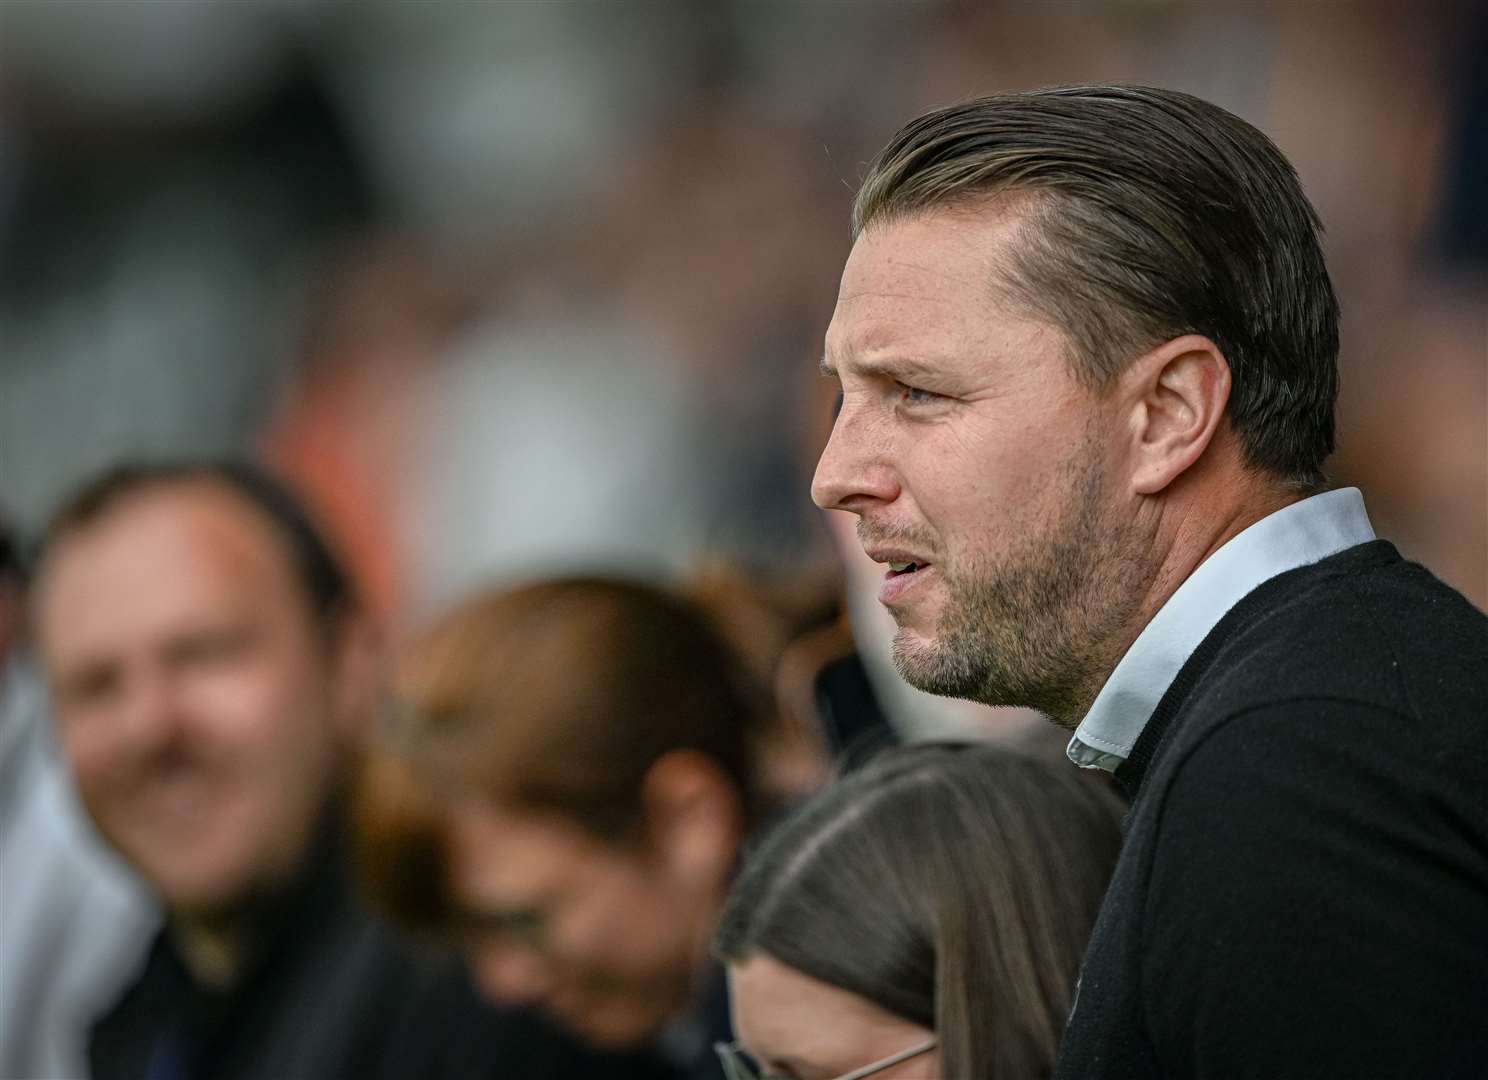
(1056, 541, 1488, 1080)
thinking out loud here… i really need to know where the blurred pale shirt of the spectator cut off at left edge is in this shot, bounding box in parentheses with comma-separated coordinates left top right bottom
(0, 517, 155, 1077)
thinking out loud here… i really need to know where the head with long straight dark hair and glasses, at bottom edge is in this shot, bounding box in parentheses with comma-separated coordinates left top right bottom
(714, 744, 1122, 1080)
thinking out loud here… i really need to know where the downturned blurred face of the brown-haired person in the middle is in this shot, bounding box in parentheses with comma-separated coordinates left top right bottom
(449, 800, 708, 1047)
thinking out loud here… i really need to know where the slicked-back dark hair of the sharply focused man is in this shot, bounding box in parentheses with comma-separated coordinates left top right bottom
(853, 85, 1338, 489)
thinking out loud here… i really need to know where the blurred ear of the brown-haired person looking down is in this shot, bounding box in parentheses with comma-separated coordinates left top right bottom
(641, 750, 744, 896)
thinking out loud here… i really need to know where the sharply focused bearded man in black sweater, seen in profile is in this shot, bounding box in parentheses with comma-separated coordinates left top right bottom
(814, 86, 1488, 1080)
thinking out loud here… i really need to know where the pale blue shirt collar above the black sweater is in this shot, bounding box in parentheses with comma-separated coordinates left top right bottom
(1065, 488, 1375, 771)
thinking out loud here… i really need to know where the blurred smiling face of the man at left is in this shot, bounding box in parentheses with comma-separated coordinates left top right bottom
(37, 480, 354, 915)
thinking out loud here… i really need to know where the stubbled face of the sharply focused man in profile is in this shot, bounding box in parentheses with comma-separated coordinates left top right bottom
(812, 210, 1149, 719)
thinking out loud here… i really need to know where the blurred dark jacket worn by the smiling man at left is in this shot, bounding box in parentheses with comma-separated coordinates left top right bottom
(89, 827, 672, 1080)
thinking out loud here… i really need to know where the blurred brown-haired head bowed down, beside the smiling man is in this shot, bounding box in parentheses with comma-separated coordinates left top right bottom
(362, 579, 760, 1046)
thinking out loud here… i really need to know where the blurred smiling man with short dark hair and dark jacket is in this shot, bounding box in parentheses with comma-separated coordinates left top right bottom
(34, 466, 651, 1080)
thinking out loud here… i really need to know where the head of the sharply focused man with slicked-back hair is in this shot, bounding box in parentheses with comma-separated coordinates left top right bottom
(812, 86, 1338, 728)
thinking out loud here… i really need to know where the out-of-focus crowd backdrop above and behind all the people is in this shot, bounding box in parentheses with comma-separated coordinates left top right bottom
(0, 0, 1488, 637)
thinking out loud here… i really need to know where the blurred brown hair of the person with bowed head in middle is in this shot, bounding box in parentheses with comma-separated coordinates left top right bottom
(359, 577, 765, 927)
